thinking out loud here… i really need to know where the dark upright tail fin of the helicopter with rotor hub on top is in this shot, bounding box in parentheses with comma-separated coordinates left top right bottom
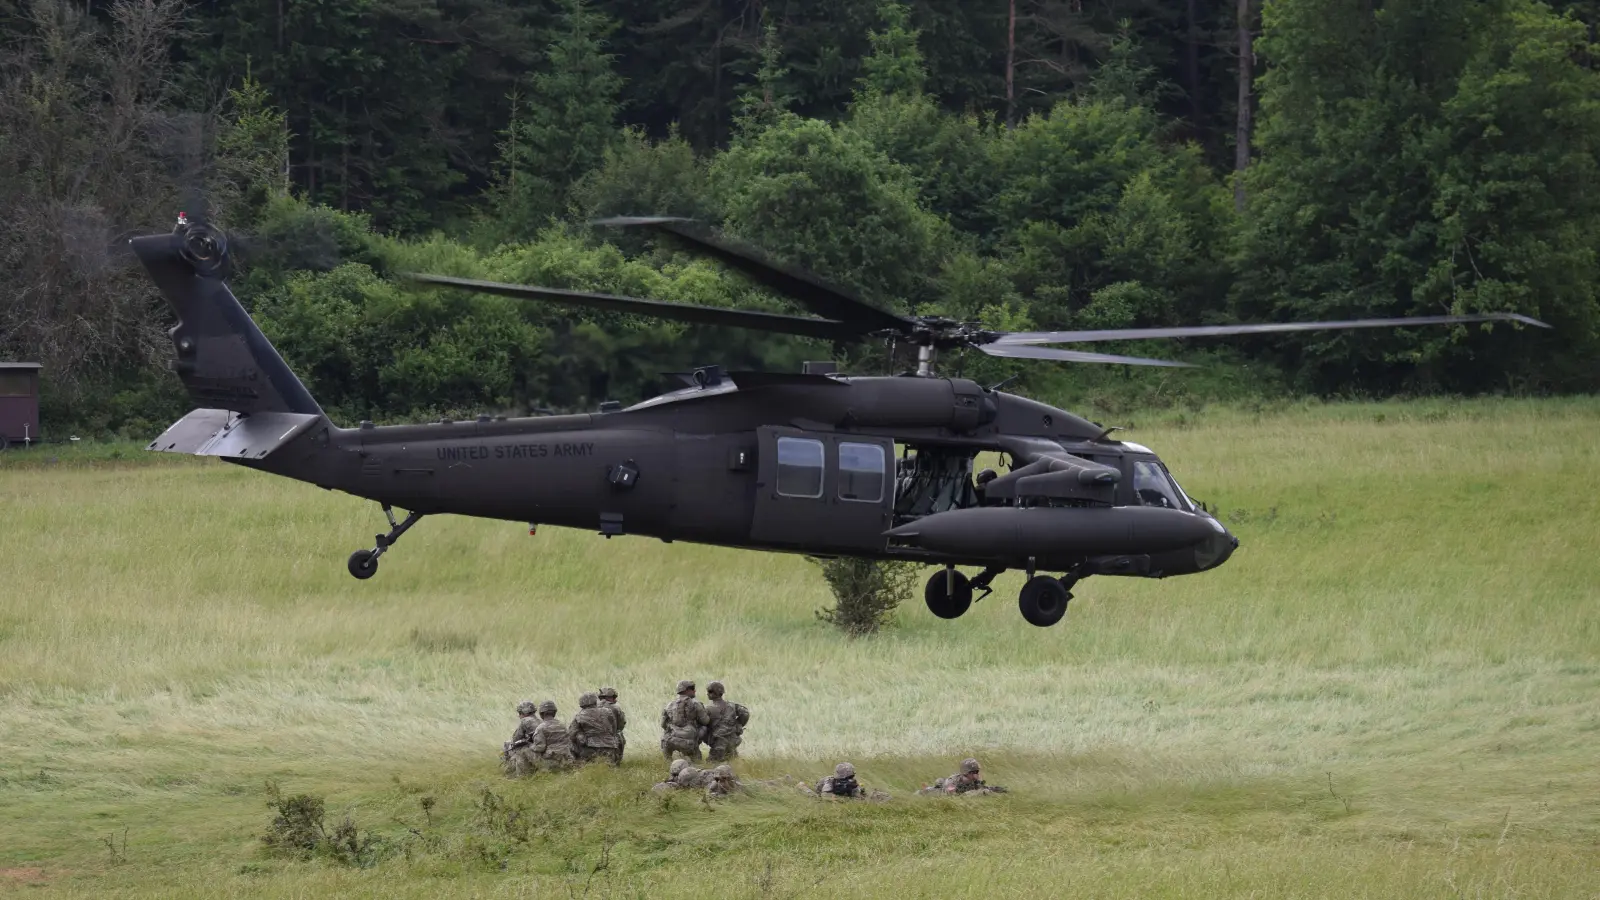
(130, 226, 325, 418)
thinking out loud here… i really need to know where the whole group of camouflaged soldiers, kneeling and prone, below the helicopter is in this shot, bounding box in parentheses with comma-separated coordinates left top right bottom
(501, 681, 1005, 801)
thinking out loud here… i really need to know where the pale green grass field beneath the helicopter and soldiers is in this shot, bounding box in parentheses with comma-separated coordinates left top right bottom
(0, 399, 1600, 898)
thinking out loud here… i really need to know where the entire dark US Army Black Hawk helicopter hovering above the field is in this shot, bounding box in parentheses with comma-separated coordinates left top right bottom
(131, 216, 1542, 626)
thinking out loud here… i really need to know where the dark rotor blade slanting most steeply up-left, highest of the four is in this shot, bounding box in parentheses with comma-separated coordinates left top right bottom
(590, 216, 915, 335)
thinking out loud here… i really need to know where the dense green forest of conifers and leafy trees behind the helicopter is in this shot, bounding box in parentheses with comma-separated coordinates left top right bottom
(0, 0, 1600, 439)
